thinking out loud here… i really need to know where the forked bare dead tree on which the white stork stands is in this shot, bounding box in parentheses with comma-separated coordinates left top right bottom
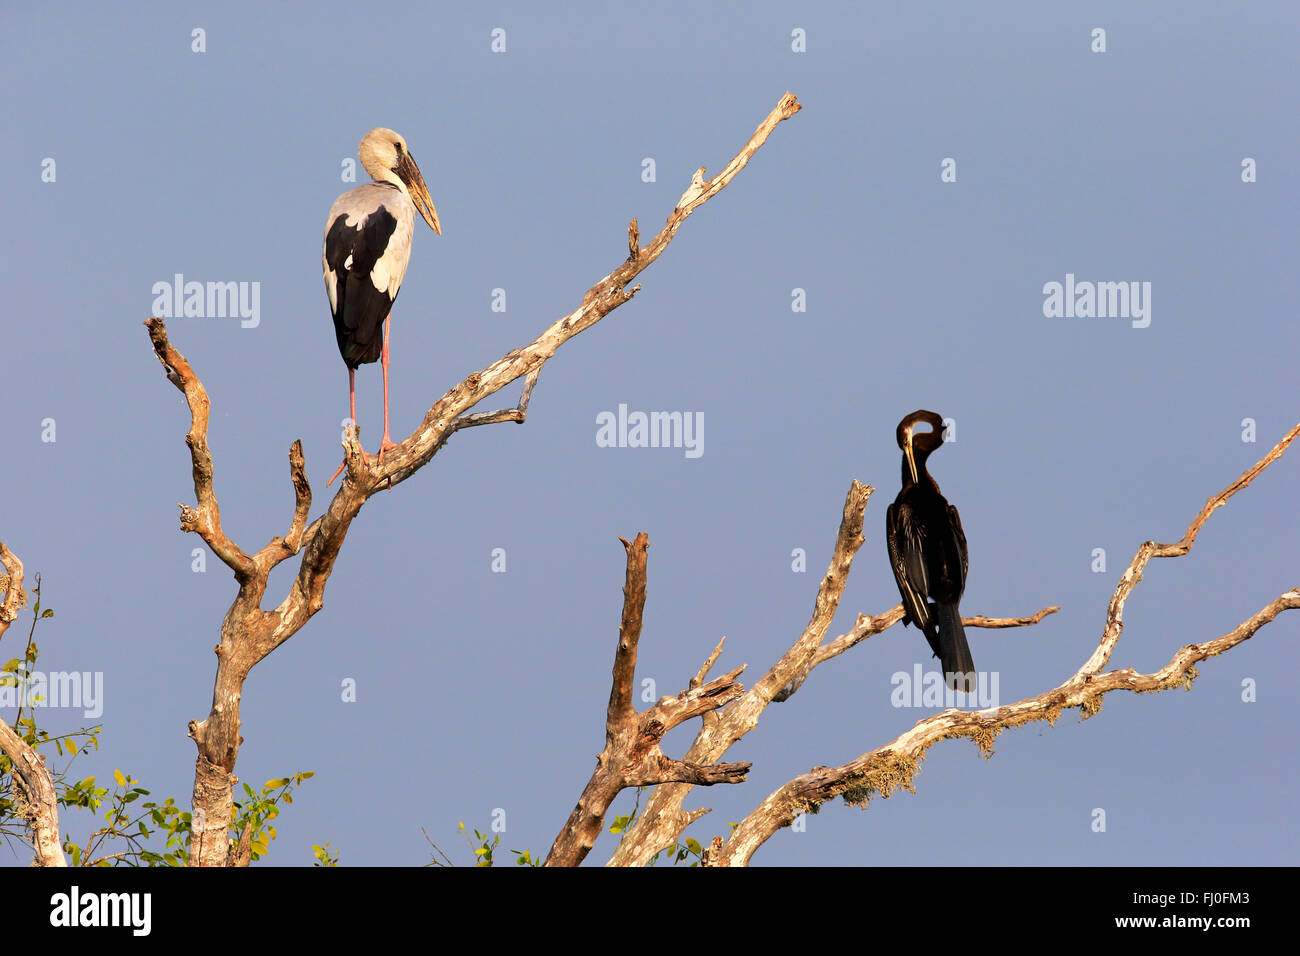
(146, 94, 801, 866)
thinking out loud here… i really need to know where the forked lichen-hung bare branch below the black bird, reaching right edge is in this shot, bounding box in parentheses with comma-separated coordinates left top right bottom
(710, 425, 1300, 866)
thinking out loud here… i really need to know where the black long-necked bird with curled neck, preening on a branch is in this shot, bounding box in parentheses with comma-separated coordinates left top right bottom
(885, 410, 975, 692)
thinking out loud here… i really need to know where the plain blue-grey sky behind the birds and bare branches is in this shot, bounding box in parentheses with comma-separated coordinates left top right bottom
(0, 3, 1300, 865)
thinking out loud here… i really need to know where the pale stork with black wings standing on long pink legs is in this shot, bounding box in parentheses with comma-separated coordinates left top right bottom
(321, 126, 442, 481)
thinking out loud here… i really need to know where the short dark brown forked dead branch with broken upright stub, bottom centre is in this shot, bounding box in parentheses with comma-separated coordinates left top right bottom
(545, 532, 750, 866)
